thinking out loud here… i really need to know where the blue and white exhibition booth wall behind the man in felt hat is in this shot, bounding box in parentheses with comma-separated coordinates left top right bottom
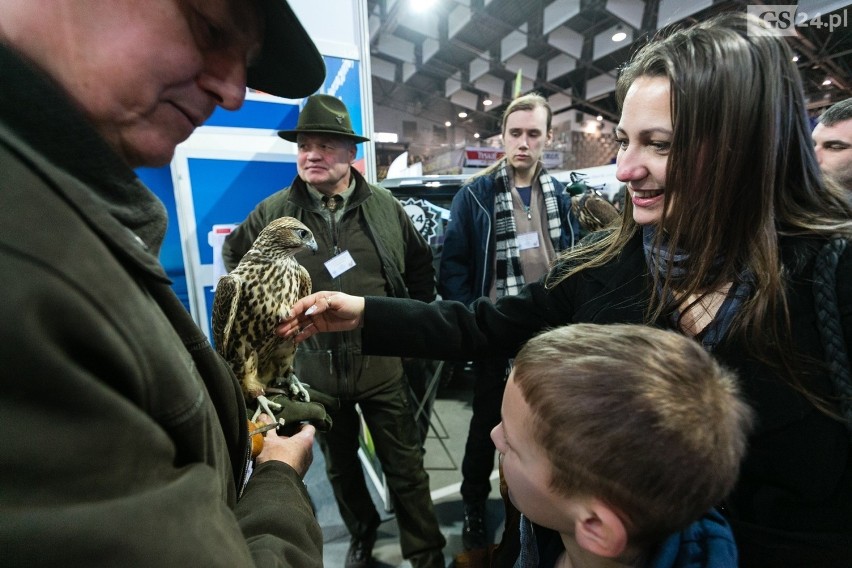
(137, 0, 376, 337)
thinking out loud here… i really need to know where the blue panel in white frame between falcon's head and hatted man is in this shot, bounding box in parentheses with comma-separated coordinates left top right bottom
(187, 158, 296, 264)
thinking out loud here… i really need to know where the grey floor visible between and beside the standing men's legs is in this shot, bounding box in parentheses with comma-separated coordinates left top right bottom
(305, 364, 503, 568)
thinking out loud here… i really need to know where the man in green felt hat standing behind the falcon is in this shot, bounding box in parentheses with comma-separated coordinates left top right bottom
(222, 94, 445, 568)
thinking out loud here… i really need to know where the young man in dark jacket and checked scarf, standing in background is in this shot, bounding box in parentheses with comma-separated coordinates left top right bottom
(438, 94, 580, 550)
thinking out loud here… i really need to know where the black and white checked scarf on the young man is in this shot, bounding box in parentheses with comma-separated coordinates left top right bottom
(494, 160, 562, 298)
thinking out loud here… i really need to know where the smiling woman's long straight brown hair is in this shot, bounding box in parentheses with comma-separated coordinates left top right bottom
(548, 13, 852, 412)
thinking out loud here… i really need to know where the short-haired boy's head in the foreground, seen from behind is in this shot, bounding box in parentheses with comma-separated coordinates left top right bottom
(491, 324, 751, 556)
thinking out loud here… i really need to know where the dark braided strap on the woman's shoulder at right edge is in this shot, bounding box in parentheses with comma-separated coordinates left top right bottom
(813, 237, 852, 436)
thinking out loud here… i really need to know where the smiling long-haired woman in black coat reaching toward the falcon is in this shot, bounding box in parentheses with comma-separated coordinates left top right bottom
(280, 10, 852, 568)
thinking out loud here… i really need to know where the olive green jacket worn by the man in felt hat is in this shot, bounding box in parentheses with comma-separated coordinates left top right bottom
(222, 173, 435, 400)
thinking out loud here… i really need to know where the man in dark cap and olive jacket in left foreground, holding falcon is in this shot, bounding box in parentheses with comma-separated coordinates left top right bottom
(0, 0, 325, 567)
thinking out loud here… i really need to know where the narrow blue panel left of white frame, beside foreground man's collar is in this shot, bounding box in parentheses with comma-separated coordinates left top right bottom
(136, 166, 189, 310)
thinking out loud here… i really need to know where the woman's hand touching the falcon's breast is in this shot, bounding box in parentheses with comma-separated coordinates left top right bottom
(275, 292, 364, 343)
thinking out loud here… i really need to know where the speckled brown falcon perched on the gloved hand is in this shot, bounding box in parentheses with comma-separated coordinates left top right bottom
(212, 217, 317, 419)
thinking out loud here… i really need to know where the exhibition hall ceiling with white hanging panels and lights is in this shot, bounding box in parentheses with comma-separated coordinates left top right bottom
(368, 0, 852, 137)
